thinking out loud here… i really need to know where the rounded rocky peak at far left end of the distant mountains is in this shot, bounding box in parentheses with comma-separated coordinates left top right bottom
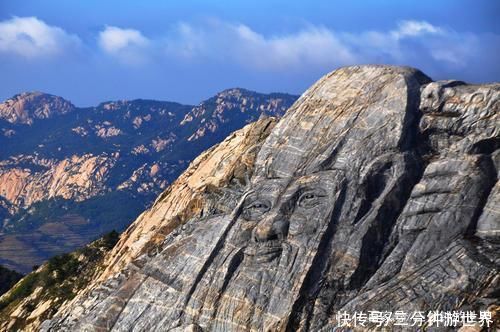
(0, 92, 75, 125)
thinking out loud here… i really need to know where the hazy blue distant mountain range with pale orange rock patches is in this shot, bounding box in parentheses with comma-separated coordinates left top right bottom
(0, 89, 298, 273)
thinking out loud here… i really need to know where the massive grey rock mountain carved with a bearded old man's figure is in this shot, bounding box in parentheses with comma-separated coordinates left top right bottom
(42, 66, 500, 331)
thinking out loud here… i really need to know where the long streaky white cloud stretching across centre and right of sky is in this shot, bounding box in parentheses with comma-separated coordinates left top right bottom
(161, 20, 477, 70)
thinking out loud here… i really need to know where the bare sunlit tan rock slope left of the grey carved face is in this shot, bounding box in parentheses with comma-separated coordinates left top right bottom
(101, 118, 276, 279)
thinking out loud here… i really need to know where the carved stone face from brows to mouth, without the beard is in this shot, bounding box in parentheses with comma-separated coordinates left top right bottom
(232, 170, 341, 263)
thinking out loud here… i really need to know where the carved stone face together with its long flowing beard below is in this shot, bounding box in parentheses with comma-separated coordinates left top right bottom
(209, 170, 345, 330)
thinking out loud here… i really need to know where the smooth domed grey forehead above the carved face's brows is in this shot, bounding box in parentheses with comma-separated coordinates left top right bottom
(255, 67, 418, 178)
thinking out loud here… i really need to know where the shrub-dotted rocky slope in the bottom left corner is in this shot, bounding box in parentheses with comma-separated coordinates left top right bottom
(0, 232, 118, 331)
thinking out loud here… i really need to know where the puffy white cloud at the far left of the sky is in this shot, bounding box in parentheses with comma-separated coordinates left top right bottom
(0, 17, 80, 58)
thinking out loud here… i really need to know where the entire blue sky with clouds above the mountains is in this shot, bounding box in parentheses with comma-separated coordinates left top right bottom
(0, 0, 500, 106)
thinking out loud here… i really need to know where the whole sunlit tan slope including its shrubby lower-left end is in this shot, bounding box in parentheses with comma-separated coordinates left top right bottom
(0, 118, 276, 331)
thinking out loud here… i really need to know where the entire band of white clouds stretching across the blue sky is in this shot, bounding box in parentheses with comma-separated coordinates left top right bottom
(0, 17, 492, 71)
